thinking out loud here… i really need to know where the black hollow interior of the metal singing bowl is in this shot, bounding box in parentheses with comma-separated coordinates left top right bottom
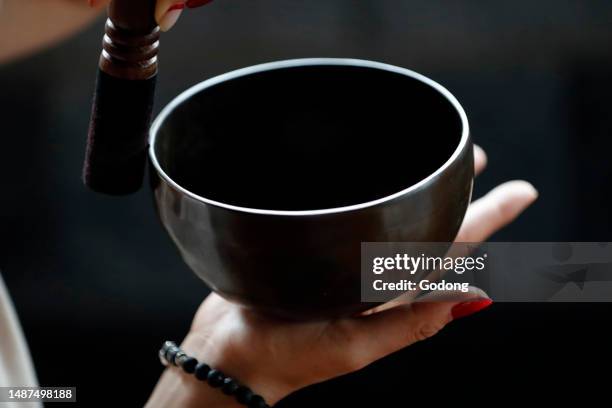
(153, 65, 462, 211)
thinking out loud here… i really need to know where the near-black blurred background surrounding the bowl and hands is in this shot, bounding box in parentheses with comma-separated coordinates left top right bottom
(0, 0, 612, 407)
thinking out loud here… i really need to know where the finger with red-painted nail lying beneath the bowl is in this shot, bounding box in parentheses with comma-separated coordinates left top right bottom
(336, 287, 492, 369)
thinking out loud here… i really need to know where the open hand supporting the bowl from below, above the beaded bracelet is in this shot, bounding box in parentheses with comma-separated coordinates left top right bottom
(185, 148, 537, 404)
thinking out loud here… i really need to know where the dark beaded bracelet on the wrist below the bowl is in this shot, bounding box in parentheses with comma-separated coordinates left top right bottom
(159, 341, 270, 408)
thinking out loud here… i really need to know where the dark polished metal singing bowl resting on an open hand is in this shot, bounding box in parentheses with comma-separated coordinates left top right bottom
(150, 59, 474, 319)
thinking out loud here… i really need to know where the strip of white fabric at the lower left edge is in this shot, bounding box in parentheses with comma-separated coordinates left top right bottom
(0, 276, 42, 408)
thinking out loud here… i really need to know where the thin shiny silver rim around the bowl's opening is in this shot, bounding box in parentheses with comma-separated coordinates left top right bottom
(148, 58, 470, 216)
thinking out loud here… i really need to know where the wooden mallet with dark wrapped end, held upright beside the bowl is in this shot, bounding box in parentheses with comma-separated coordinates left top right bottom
(83, 0, 160, 195)
